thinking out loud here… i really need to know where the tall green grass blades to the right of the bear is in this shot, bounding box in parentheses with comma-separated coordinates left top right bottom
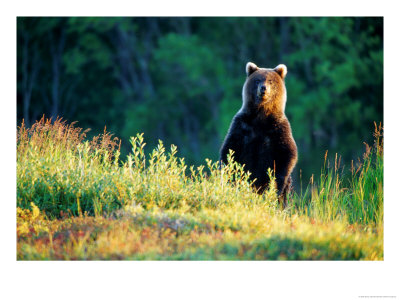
(291, 124, 383, 225)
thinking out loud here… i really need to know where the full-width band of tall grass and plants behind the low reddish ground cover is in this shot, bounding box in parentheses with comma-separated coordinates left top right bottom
(17, 118, 383, 225)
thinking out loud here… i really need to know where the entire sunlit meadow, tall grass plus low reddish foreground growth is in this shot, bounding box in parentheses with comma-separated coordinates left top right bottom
(17, 118, 383, 260)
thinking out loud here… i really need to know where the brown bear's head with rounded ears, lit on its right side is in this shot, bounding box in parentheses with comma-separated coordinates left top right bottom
(242, 62, 287, 116)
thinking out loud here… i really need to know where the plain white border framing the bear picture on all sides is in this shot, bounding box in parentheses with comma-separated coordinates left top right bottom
(0, 0, 400, 299)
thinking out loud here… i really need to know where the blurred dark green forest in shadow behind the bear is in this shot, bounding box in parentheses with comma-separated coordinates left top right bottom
(17, 17, 383, 186)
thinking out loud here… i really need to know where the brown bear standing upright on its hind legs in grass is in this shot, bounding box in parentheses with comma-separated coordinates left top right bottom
(220, 62, 297, 205)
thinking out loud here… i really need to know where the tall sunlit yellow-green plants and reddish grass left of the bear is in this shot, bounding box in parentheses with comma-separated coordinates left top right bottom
(17, 118, 276, 217)
